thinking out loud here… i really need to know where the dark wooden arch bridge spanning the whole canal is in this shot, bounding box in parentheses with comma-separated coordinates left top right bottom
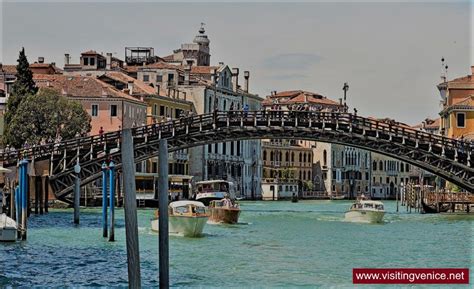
(0, 111, 474, 200)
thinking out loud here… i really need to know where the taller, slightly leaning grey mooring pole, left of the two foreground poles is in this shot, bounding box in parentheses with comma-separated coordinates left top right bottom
(121, 129, 141, 289)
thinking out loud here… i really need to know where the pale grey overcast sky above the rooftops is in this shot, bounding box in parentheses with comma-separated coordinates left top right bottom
(0, 1, 474, 124)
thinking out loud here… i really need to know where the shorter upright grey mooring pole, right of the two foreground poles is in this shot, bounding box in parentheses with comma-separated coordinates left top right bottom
(158, 139, 170, 288)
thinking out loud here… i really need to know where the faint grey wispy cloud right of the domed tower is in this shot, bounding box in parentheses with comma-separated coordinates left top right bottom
(263, 53, 322, 69)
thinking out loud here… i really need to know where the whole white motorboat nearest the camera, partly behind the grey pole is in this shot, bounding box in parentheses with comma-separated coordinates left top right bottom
(151, 201, 209, 237)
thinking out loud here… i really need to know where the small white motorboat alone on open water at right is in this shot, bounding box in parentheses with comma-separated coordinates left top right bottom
(345, 200, 385, 223)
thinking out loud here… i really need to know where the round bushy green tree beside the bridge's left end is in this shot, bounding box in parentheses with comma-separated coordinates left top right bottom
(5, 89, 91, 148)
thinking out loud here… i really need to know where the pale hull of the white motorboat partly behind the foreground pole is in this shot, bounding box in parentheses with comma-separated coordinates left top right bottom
(151, 216, 208, 237)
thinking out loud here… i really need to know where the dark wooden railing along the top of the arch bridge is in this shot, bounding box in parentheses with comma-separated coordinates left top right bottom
(0, 110, 474, 162)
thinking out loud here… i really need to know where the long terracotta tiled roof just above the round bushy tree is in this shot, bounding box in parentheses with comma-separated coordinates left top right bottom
(33, 74, 143, 103)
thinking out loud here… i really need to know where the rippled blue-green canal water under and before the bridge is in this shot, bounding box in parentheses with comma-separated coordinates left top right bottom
(0, 201, 474, 288)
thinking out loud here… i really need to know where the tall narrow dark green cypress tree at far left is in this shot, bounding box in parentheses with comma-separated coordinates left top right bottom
(5, 48, 38, 126)
